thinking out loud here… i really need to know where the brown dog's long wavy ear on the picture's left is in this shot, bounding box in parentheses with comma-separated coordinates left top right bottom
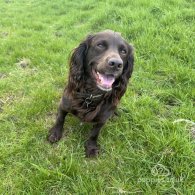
(69, 35, 93, 89)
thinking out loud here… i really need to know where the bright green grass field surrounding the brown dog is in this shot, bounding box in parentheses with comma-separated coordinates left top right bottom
(0, 0, 195, 195)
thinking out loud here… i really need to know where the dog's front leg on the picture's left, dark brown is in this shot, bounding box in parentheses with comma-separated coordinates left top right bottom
(48, 106, 68, 143)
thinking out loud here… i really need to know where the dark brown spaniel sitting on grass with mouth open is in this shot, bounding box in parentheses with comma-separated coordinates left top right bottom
(48, 30, 134, 157)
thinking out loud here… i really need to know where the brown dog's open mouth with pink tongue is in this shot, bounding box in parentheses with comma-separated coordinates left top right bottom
(94, 71, 115, 91)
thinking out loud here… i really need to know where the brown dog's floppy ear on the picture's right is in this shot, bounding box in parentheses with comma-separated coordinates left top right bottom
(112, 45, 134, 100)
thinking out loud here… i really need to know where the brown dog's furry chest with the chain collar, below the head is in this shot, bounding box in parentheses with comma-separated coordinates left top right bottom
(62, 90, 116, 122)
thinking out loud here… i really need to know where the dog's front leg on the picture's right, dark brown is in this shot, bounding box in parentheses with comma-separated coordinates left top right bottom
(85, 123, 104, 157)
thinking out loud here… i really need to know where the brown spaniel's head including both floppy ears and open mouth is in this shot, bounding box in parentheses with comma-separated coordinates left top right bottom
(69, 30, 134, 93)
